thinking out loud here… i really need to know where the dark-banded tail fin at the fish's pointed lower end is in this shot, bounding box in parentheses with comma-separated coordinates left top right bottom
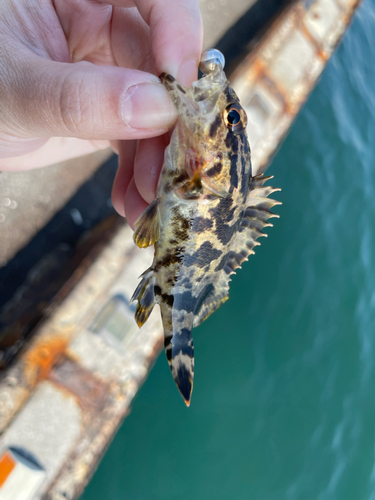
(161, 307, 194, 406)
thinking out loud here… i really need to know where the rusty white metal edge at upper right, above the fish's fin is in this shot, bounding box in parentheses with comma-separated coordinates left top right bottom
(230, 0, 359, 174)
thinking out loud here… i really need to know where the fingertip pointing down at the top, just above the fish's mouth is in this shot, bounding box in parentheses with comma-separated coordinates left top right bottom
(95, 0, 203, 85)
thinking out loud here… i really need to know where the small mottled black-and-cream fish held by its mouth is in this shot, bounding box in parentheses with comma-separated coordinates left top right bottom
(131, 49, 280, 406)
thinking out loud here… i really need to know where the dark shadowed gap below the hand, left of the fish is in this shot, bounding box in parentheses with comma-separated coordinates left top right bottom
(0, 152, 120, 369)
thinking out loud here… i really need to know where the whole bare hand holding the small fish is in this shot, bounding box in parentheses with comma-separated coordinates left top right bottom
(0, 0, 202, 226)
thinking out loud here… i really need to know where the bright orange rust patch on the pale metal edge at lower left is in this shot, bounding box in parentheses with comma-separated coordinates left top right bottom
(24, 337, 70, 385)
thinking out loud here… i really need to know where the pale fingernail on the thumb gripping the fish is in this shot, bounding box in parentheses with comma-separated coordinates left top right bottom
(121, 83, 177, 129)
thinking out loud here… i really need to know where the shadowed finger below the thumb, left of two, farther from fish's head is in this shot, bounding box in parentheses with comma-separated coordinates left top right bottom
(112, 141, 137, 217)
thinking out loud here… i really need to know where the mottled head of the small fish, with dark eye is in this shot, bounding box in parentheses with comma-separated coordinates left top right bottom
(160, 51, 250, 197)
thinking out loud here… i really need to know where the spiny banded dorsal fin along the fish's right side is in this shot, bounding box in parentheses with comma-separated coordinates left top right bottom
(194, 175, 281, 327)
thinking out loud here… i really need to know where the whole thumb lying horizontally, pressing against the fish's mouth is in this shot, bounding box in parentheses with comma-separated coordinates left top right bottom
(0, 57, 177, 143)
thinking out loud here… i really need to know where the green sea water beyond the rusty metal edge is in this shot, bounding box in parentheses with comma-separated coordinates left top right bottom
(82, 0, 375, 500)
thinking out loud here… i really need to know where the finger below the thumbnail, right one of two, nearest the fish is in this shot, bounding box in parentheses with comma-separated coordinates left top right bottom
(134, 134, 169, 203)
